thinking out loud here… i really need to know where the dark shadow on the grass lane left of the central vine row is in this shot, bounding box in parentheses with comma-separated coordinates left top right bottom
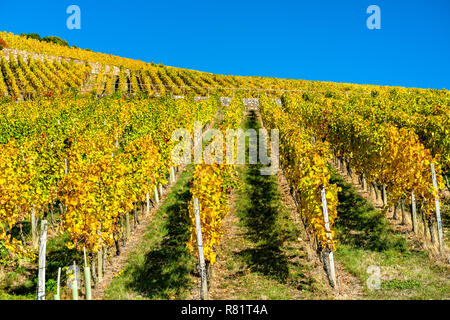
(128, 173, 193, 299)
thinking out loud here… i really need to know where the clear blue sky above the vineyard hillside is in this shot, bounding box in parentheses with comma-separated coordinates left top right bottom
(0, 0, 450, 89)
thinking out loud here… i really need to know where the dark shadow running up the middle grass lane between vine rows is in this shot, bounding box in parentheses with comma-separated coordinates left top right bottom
(236, 112, 295, 282)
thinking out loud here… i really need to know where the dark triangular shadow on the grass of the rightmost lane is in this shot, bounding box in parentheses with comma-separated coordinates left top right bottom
(330, 174, 408, 252)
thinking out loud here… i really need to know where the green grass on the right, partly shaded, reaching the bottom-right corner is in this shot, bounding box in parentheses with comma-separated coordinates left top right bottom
(332, 174, 450, 299)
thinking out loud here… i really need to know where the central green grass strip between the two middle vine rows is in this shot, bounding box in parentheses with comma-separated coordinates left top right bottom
(211, 110, 326, 300)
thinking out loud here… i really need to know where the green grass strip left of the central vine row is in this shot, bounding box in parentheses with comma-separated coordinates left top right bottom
(104, 166, 195, 300)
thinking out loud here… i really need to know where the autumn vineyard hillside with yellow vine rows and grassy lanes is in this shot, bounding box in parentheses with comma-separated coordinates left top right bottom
(0, 32, 450, 300)
